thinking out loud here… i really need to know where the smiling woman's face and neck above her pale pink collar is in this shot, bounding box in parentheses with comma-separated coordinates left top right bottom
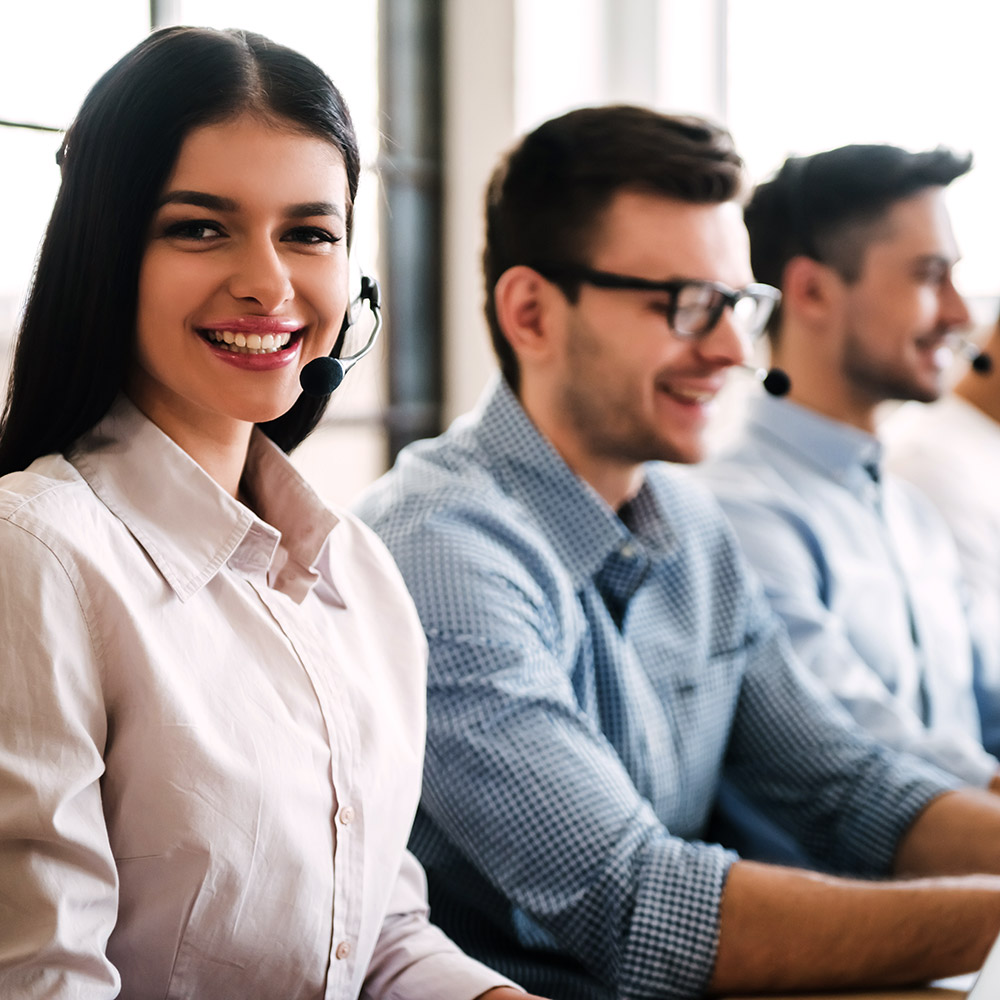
(127, 114, 351, 494)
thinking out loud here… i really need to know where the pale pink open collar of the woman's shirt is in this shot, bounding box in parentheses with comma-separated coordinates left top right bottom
(67, 396, 337, 601)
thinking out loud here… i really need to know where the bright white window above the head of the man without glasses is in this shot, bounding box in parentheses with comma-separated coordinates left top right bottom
(727, 0, 1000, 310)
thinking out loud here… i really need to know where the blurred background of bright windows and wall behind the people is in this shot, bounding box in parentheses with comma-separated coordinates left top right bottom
(0, 0, 1000, 503)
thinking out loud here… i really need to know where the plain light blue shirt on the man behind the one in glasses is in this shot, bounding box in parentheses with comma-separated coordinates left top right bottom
(696, 396, 997, 786)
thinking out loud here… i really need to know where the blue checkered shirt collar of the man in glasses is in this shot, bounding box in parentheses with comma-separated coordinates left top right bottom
(477, 378, 673, 587)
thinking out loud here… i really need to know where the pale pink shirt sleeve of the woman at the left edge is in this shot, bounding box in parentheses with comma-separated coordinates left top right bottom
(0, 520, 119, 1000)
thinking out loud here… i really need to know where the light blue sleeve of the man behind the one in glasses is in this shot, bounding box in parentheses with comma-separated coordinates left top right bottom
(708, 489, 997, 787)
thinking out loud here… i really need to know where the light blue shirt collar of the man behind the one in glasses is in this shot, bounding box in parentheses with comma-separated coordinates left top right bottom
(748, 396, 882, 489)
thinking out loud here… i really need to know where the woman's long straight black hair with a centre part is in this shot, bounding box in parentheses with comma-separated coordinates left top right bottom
(0, 27, 360, 475)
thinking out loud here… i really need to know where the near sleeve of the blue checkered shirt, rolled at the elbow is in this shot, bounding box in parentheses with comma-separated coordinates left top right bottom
(376, 509, 734, 998)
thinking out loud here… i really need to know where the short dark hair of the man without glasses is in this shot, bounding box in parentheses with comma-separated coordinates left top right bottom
(743, 145, 972, 343)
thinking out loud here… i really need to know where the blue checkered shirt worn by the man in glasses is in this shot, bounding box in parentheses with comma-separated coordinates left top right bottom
(359, 381, 948, 1000)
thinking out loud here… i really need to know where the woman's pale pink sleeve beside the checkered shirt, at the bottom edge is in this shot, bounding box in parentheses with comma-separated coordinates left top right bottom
(361, 852, 519, 1000)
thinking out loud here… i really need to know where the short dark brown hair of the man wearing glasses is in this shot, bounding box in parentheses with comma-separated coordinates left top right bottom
(483, 105, 744, 391)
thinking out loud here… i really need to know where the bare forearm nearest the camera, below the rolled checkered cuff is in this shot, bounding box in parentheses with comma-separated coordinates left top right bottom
(710, 861, 1000, 993)
